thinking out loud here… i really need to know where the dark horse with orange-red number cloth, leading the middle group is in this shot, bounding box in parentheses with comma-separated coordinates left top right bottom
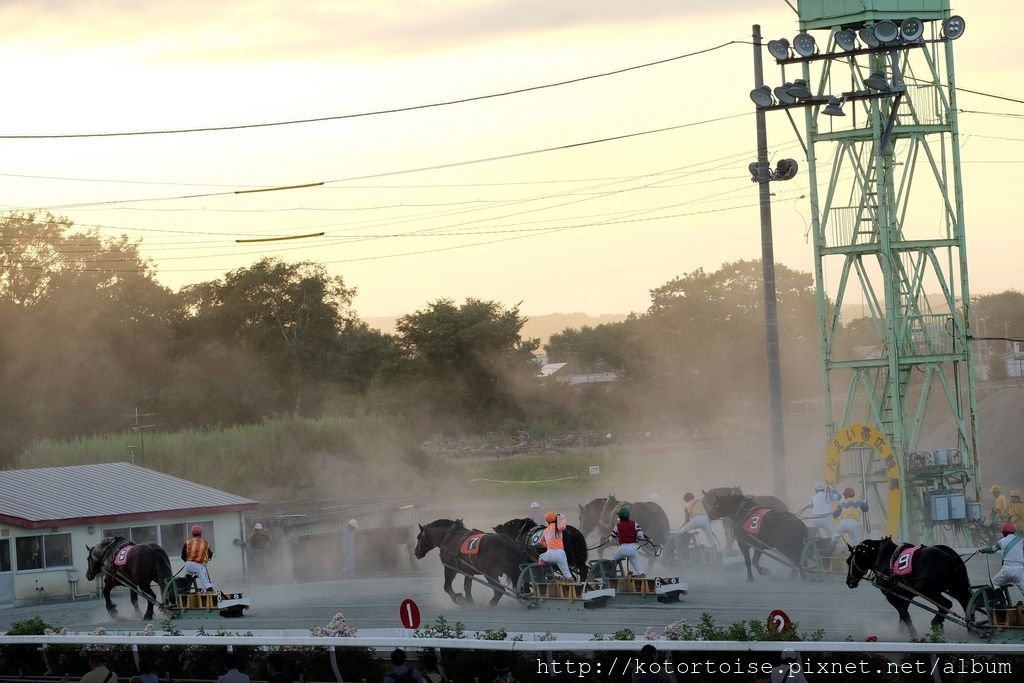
(416, 519, 529, 607)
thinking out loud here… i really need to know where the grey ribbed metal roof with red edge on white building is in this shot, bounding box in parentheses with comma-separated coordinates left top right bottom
(0, 463, 256, 528)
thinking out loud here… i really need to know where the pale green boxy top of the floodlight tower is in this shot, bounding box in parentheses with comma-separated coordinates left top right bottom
(797, 0, 949, 31)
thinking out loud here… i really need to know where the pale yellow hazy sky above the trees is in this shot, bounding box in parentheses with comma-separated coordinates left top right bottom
(0, 0, 1024, 316)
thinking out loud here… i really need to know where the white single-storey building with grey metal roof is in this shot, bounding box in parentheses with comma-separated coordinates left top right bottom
(0, 463, 256, 606)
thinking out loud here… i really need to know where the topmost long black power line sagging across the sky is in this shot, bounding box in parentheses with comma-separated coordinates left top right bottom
(0, 40, 737, 140)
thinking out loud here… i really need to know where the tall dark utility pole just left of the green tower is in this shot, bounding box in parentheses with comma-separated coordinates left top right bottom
(754, 24, 785, 500)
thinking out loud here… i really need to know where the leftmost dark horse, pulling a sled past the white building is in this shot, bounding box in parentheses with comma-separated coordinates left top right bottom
(85, 536, 174, 621)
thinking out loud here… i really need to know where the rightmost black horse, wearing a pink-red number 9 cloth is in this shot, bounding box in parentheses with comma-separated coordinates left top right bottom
(846, 537, 973, 638)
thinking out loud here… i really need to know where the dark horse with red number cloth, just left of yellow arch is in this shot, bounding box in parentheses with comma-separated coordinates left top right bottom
(702, 486, 807, 582)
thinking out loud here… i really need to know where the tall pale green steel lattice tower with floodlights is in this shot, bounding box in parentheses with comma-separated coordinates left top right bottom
(759, 0, 981, 542)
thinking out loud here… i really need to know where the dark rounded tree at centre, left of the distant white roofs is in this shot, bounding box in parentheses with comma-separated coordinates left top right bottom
(381, 299, 540, 420)
